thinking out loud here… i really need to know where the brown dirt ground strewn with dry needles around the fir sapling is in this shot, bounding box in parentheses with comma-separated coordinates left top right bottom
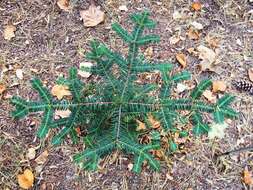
(0, 0, 253, 190)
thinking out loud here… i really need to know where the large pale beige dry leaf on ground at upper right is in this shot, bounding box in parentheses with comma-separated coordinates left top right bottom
(197, 45, 217, 71)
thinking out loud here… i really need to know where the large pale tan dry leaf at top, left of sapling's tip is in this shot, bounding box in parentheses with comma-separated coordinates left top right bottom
(80, 4, 105, 27)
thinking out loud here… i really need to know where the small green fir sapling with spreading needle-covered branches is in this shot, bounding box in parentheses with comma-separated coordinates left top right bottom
(8, 12, 237, 173)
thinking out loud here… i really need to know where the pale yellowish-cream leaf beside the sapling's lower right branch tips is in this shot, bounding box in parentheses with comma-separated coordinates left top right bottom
(208, 123, 228, 139)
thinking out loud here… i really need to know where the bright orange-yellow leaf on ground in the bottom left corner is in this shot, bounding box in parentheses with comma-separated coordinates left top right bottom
(17, 169, 34, 189)
